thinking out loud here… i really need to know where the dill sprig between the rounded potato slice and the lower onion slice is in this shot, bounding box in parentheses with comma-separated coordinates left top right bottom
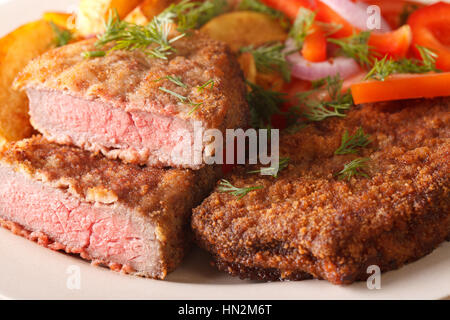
(240, 42, 291, 82)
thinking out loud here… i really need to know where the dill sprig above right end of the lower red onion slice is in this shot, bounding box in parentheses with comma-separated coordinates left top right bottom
(328, 31, 374, 67)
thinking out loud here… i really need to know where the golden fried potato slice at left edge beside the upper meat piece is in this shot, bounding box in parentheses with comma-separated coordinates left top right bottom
(0, 20, 54, 145)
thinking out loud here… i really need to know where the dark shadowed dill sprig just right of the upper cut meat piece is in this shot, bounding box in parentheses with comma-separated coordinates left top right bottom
(247, 81, 286, 129)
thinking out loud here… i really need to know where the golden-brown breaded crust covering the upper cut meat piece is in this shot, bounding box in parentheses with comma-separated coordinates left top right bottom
(15, 33, 248, 129)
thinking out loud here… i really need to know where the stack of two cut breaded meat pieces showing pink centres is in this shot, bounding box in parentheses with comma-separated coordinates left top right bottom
(0, 34, 248, 279)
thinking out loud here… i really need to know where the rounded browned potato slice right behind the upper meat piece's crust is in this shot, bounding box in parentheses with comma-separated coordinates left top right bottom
(200, 11, 287, 52)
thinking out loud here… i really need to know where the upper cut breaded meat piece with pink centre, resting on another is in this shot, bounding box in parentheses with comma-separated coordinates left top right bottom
(15, 33, 248, 169)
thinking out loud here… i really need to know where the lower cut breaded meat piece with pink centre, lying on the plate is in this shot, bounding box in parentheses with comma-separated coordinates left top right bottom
(0, 137, 220, 279)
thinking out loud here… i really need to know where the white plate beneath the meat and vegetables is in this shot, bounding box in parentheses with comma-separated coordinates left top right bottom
(0, 0, 450, 299)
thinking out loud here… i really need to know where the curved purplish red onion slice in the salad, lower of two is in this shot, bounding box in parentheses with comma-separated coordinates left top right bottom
(285, 39, 360, 81)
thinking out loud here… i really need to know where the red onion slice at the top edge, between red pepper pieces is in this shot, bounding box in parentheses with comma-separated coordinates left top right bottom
(321, 0, 391, 33)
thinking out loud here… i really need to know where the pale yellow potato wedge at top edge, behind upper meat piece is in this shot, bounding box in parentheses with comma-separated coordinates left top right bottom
(75, 0, 142, 36)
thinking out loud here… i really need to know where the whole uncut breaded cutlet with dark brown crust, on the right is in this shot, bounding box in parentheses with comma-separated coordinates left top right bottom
(192, 99, 450, 284)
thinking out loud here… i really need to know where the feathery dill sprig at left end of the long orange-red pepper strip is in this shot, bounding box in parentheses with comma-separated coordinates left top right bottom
(297, 76, 353, 121)
